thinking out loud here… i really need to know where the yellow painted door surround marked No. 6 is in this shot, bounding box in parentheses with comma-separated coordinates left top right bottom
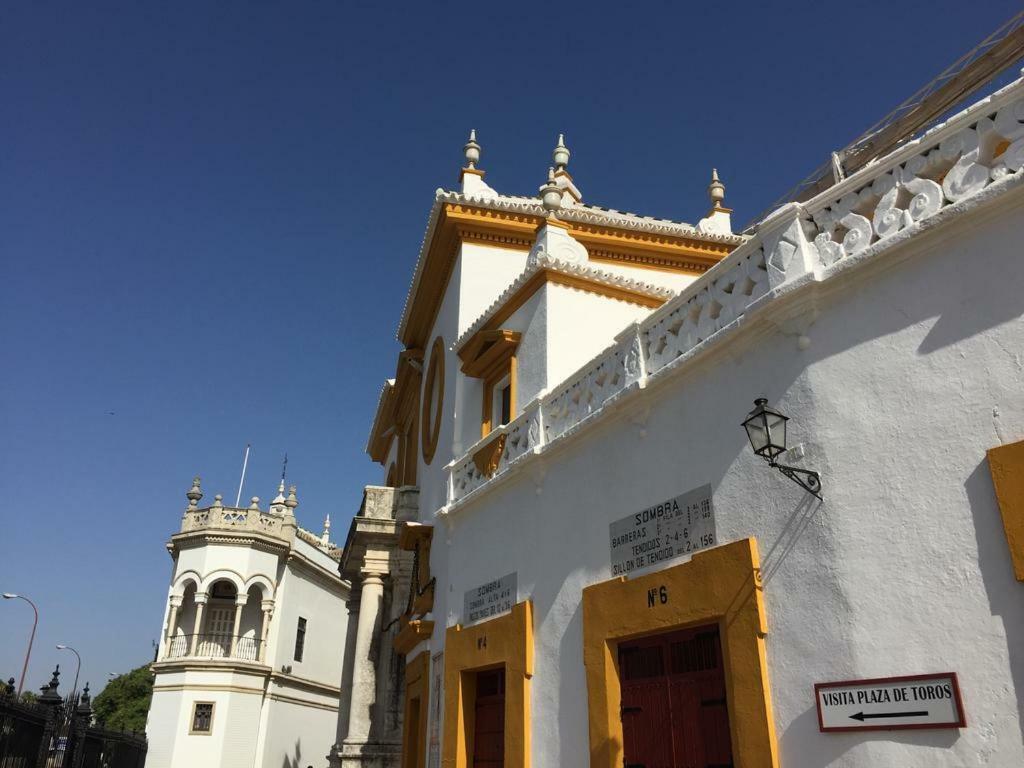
(583, 539, 778, 768)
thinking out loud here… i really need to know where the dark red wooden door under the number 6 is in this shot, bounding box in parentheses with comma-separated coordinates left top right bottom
(618, 627, 732, 768)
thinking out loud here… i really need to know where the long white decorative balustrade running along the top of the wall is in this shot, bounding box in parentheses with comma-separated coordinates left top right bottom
(445, 80, 1024, 511)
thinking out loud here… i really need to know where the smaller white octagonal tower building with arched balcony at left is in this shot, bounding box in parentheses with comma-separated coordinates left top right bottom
(146, 478, 349, 768)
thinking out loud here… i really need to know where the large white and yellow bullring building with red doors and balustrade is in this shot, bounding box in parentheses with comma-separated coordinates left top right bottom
(358, 73, 1024, 768)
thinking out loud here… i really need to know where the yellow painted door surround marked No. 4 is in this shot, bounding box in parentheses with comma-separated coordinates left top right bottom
(441, 600, 532, 768)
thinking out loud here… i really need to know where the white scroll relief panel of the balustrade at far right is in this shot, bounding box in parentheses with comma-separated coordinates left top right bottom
(812, 99, 1024, 266)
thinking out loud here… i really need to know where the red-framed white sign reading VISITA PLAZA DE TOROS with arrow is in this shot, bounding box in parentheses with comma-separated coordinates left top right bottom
(814, 672, 966, 731)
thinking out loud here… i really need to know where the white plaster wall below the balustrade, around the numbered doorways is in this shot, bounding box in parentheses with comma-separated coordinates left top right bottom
(421, 195, 1024, 768)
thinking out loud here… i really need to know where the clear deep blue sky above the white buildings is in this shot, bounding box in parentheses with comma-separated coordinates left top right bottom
(0, 0, 1018, 690)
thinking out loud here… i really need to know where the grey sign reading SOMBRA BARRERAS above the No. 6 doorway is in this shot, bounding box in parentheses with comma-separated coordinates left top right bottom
(609, 485, 718, 575)
